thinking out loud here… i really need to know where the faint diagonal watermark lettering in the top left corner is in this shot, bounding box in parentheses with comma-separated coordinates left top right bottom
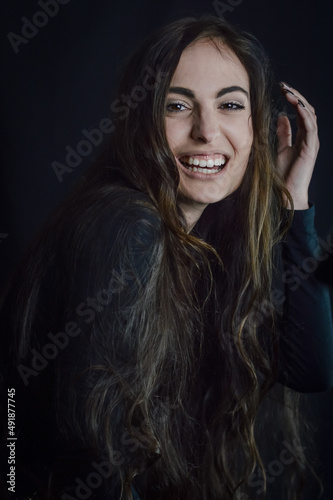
(7, 0, 71, 54)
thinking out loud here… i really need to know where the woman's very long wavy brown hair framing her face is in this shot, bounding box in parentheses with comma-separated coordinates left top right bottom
(1, 16, 314, 500)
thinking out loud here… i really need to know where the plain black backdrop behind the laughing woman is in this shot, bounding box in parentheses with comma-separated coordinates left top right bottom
(0, 0, 333, 500)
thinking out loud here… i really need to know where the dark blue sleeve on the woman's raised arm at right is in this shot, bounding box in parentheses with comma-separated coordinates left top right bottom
(277, 206, 333, 392)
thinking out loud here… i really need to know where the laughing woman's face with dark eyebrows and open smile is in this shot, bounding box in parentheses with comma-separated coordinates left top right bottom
(166, 40, 253, 219)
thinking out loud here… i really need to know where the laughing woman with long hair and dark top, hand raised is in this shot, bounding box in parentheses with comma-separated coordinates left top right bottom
(3, 13, 333, 500)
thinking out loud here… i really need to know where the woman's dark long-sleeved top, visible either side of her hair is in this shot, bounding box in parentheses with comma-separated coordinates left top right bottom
(3, 188, 333, 500)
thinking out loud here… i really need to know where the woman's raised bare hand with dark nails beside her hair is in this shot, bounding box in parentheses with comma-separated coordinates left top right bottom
(277, 83, 319, 210)
